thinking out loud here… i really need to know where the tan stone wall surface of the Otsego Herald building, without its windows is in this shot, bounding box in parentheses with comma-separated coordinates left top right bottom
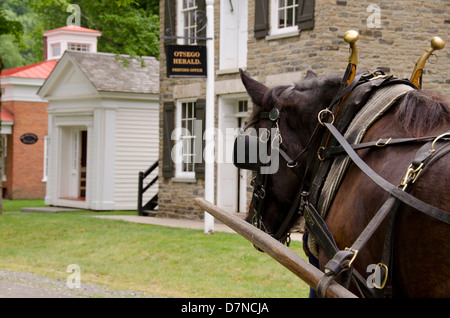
(159, 0, 450, 218)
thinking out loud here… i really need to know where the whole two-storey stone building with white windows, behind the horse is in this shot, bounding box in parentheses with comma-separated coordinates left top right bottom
(159, 0, 450, 218)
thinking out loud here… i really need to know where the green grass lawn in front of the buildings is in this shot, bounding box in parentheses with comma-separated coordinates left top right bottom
(0, 200, 309, 298)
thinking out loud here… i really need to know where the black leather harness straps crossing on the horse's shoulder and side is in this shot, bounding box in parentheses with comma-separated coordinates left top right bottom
(314, 124, 450, 296)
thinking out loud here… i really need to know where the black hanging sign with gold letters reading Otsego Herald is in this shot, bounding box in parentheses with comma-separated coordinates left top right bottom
(167, 45, 206, 77)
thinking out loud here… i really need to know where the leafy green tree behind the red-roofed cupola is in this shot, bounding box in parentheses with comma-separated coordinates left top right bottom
(29, 0, 159, 62)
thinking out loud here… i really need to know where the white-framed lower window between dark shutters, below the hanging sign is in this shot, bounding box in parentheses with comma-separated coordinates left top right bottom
(175, 98, 197, 179)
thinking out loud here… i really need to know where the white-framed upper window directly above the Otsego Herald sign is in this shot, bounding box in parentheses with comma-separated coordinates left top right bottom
(177, 0, 198, 45)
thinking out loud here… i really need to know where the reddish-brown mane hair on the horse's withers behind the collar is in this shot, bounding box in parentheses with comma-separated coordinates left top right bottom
(396, 90, 450, 136)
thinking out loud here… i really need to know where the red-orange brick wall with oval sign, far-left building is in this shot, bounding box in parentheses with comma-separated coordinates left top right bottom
(2, 101, 48, 199)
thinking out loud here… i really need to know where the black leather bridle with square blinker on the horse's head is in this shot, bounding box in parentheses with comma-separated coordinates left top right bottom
(234, 70, 385, 243)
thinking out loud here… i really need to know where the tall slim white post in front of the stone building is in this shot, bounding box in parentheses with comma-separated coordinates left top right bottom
(204, 0, 215, 234)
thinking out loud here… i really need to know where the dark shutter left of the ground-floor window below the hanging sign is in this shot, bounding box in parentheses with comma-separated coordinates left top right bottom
(162, 102, 175, 178)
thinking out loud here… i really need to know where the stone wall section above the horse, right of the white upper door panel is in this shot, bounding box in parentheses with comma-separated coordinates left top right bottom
(248, 0, 450, 96)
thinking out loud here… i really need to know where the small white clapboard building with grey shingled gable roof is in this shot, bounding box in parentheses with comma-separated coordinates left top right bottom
(38, 51, 159, 211)
